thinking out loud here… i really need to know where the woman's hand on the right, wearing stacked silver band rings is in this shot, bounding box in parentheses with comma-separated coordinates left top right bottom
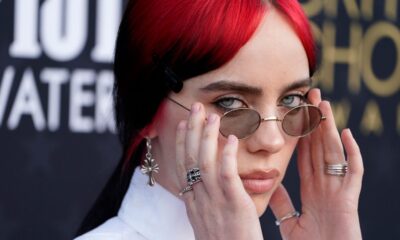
(270, 89, 363, 240)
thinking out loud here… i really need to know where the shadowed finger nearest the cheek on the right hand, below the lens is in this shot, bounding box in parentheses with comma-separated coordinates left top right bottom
(297, 136, 313, 184)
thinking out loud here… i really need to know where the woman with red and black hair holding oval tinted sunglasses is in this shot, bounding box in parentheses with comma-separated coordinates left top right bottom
(74, 0, 363, 240)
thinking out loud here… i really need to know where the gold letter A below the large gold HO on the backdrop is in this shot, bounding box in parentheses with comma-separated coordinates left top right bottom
(360, 100, 383, 136)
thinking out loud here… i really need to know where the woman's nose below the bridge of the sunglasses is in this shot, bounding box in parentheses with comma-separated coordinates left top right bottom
(247, 117, 285, 153)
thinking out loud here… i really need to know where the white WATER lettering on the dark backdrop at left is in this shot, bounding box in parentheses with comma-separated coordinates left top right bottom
(0, 66, 115, 133)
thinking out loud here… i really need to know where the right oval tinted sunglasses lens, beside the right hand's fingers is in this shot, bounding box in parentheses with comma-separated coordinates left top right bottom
(282, 105, 321, 137)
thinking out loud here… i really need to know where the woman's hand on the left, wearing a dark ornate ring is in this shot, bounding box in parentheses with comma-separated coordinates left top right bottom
(176, 103, 263, 240)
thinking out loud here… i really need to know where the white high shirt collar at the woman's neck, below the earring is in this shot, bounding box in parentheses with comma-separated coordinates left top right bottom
(118, 167, 195, 240)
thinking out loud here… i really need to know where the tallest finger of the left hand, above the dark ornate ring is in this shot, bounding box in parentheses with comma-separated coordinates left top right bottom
(185, 103, 205, 169)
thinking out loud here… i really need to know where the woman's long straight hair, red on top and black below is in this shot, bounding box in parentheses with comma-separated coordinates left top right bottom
(77, 0, 316, 235)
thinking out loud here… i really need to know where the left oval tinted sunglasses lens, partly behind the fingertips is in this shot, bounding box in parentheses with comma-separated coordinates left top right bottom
(219, 108, 260, 139)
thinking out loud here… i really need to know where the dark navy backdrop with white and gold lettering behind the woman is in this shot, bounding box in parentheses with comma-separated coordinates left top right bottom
(0, 0, 400, 240)
